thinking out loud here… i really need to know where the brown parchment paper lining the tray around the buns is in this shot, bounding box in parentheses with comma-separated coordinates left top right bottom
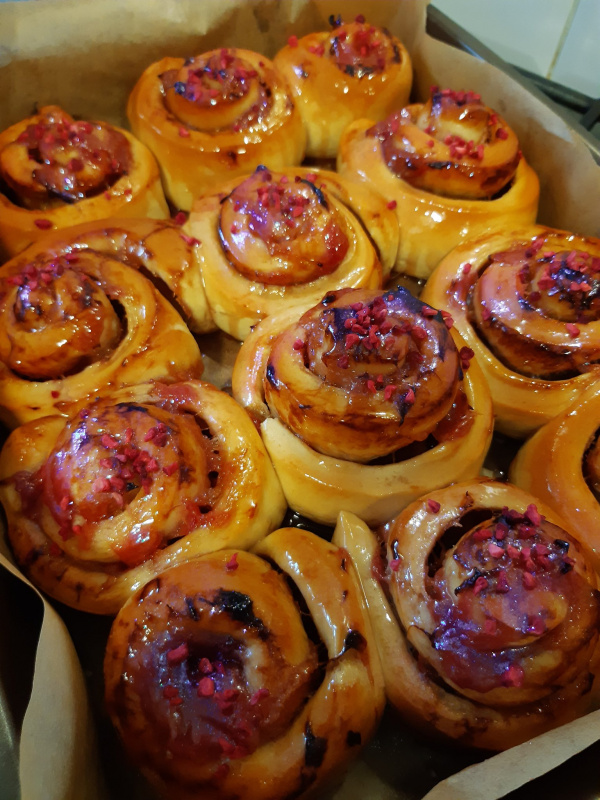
(0, 0, 600, 800)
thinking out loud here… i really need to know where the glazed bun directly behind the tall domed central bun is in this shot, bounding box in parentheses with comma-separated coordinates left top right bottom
(185, 167, 399, 339)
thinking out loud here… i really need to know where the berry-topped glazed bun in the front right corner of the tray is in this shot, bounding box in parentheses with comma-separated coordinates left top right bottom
(334, 480, 600, 749)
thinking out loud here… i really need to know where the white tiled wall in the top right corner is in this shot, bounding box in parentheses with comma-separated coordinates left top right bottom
(432, 0, 600, 98)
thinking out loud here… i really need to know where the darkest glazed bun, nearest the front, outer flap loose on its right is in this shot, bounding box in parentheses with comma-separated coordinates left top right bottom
(105, 528, 384, 800)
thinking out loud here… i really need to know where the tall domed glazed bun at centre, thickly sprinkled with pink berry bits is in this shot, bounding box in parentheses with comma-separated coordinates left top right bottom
(232, 289, 492, 524)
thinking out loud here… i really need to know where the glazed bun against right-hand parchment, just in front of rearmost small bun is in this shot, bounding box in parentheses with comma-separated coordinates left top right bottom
(338, 87, 539, 278)
